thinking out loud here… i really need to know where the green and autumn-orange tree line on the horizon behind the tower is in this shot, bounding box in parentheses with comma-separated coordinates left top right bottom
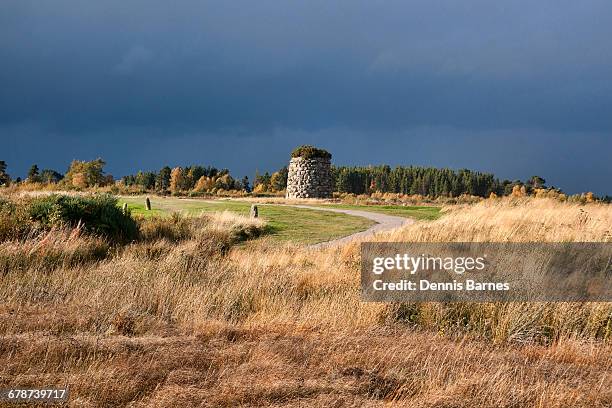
(0, 158, 612, 202)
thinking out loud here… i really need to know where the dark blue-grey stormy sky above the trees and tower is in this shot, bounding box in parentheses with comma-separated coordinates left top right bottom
(0, 0, 612, 194)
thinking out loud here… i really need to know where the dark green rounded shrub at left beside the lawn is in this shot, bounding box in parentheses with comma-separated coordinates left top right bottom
(28, 194, 138, 242)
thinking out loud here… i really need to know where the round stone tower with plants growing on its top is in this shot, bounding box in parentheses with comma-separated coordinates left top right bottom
(286, 146, 332, 198)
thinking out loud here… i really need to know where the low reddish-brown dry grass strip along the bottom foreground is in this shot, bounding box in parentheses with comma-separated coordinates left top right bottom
(0, 327, 612, 407)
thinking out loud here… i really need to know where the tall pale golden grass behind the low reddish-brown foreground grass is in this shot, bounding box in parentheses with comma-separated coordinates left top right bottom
(0, 200, 612, 342)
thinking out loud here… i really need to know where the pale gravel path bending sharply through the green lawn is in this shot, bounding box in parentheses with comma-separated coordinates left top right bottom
(291, 205, 414, 248)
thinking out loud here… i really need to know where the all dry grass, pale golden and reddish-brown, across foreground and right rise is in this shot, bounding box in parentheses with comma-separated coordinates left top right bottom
(0, 200, 612, 407)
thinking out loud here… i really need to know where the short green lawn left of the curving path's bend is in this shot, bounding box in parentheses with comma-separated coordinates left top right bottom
(119, 197, 374, 244)
